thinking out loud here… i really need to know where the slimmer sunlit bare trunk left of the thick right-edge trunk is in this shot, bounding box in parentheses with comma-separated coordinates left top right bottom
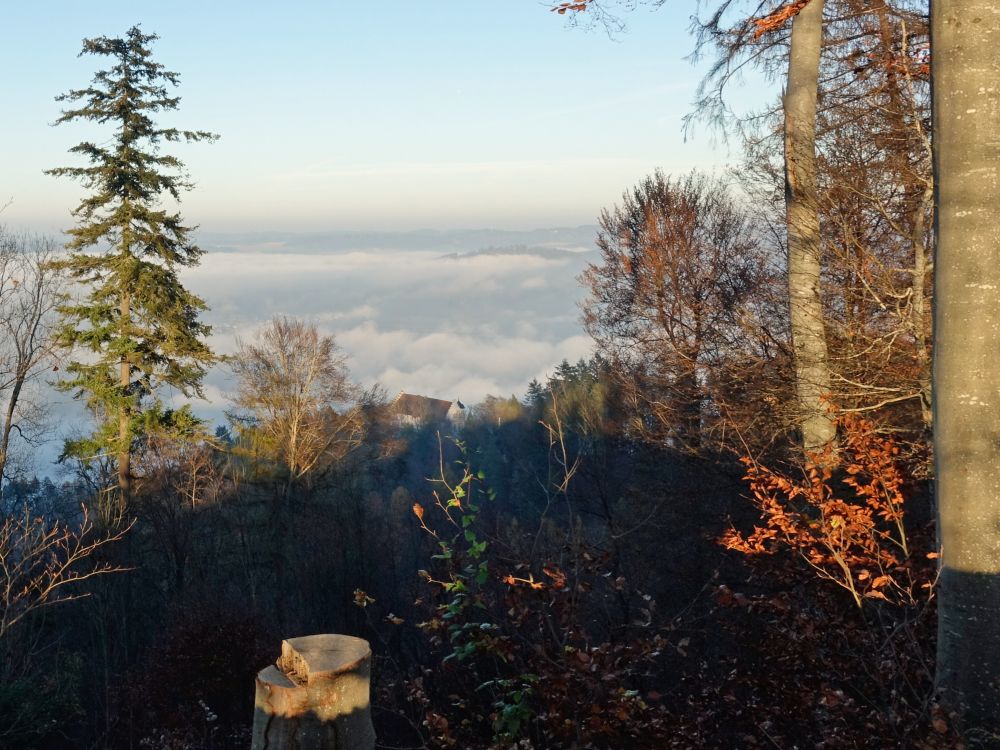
(784, 0, 835, 450)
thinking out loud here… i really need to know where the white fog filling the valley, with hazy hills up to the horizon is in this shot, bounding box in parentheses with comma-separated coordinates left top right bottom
(30, 226, 596, 474)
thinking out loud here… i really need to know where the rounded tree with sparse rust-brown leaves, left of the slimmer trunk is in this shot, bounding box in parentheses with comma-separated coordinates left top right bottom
(582, 172, 783, 452)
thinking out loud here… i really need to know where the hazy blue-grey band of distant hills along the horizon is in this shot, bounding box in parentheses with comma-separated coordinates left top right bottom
(198, 224, 597, 254)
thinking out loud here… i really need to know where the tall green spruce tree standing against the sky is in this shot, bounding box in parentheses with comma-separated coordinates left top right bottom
(47, 26, 217, 500)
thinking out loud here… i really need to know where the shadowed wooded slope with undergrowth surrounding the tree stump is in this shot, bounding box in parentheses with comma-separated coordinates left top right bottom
(0, 338, 940, 748)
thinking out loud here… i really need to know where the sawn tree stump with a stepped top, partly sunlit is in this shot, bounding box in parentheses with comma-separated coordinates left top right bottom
(250, 635, 375, 750)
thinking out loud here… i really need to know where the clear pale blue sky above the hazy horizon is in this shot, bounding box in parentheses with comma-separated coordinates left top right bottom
(0, 0, 764, 231)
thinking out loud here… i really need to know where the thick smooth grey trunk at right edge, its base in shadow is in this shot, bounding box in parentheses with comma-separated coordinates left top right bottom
(931, 0, 1000, 747)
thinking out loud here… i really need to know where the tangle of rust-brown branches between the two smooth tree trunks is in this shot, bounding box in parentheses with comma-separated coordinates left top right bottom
(817, 3, 933, 446)
